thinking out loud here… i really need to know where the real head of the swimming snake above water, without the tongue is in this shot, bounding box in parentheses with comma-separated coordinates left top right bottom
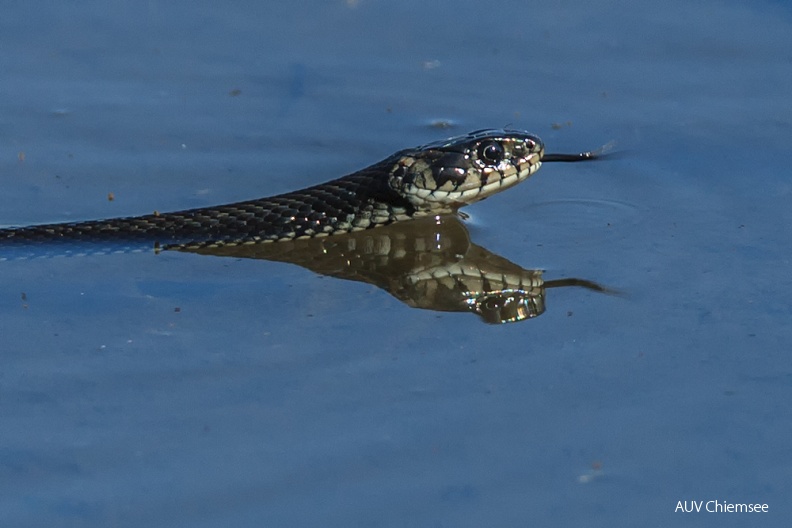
(388, 130, 544, 212)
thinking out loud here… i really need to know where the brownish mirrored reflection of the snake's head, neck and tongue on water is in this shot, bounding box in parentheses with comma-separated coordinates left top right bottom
(178, 215, 609, 323)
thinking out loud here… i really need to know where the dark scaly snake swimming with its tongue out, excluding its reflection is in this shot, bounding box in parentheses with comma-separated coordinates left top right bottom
(0, 129, 601, 247)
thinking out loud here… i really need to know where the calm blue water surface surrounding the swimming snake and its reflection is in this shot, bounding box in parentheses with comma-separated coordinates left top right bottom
(0, 0, 792, 527)
